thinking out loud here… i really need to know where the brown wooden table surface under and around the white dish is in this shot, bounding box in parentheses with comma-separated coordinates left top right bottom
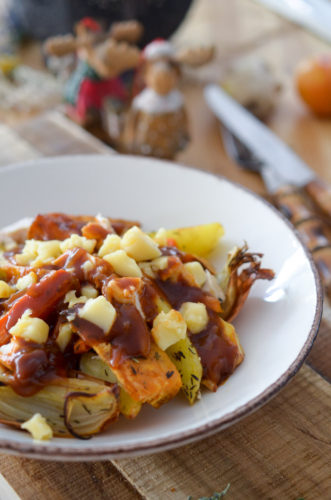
(0, 0, 331, 500)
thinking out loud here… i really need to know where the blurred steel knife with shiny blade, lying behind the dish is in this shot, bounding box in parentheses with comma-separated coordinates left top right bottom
(204, 84, 331, 221)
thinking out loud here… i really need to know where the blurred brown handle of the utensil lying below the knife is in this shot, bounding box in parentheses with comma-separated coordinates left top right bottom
(273, 186, 331, 289)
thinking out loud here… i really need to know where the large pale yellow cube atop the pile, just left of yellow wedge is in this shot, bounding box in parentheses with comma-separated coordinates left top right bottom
(121, 226, 161, 262)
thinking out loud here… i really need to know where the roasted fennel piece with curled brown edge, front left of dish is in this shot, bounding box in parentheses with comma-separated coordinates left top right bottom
(0, 378, 119, 438)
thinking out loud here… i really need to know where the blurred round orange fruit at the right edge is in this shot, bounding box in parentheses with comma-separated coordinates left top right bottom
(296, 54, 331, 116)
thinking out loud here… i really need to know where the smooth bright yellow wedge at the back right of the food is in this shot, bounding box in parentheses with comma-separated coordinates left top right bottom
(154, 222, 224, 257)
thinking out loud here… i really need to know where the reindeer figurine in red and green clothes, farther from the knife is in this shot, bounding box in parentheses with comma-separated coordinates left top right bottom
(45, 18, 143, 126)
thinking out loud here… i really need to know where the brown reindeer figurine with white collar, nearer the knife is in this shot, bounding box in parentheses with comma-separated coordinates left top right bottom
(122, 40, 214, 159)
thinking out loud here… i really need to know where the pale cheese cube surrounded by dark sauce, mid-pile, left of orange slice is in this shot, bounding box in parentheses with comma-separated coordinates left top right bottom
(78, 295, 116, 333)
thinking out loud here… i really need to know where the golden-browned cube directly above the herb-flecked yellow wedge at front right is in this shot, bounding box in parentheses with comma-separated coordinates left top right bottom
(152, 309, 187, 351)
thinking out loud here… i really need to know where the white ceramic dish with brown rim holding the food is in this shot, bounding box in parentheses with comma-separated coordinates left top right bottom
(0, 156, 322, 460)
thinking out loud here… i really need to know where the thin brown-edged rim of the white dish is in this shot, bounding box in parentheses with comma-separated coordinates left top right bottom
(0, 154, 323, 461)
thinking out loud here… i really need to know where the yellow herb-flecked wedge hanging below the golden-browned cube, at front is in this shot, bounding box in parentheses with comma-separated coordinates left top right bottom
(166, 337, 202, 405)
